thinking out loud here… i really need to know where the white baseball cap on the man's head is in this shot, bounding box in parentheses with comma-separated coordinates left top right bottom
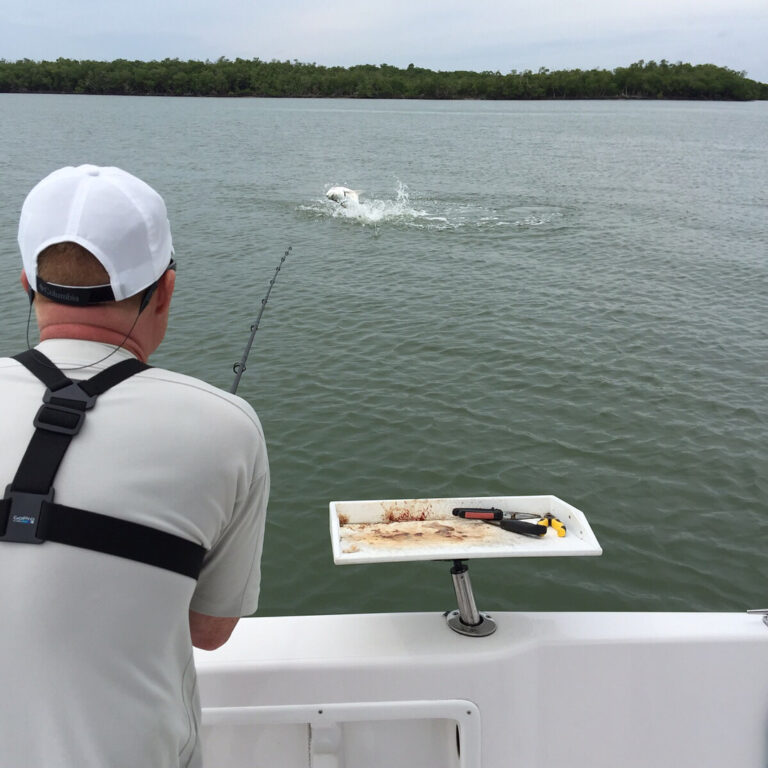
(19, 165, 173, 301)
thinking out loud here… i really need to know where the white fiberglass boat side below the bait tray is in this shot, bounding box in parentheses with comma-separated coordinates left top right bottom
(196, 496, 768, 768)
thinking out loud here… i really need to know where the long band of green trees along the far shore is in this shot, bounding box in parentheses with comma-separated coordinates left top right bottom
(0, 58, 768, 101)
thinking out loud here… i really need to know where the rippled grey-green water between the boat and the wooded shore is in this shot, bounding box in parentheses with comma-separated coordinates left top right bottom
(0, 95, 768, 615)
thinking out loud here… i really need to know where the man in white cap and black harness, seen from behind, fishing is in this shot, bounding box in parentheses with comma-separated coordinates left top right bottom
(0, 165, 269, 768)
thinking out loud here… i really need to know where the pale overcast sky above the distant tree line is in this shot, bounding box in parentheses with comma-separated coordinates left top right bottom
(6, 0, 768, 82)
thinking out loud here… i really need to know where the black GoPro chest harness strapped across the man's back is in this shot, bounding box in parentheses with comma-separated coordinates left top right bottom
(0, 349, 206, 579)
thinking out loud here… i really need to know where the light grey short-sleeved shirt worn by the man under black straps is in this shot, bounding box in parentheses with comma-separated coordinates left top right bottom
(0, 340, 269, 768)
